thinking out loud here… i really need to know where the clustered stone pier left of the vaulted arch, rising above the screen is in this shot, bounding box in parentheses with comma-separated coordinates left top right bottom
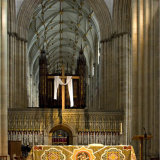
(7, 0, 28, 108)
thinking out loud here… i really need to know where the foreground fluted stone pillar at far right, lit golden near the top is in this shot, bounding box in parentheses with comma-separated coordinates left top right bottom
(132, 0, 160, 158)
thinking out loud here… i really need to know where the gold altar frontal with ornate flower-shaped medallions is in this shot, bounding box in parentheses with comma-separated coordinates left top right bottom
(27, 144, 136, 160)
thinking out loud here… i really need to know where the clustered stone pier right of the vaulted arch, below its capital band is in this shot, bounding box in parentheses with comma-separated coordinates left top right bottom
(99, 32, 132, 144)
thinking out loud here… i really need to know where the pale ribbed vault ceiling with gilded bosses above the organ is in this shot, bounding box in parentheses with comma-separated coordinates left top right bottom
(28, 0, 99, 73)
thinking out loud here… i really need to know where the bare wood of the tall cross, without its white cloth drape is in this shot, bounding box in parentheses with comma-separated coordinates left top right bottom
(48, 65, 80, 110)
